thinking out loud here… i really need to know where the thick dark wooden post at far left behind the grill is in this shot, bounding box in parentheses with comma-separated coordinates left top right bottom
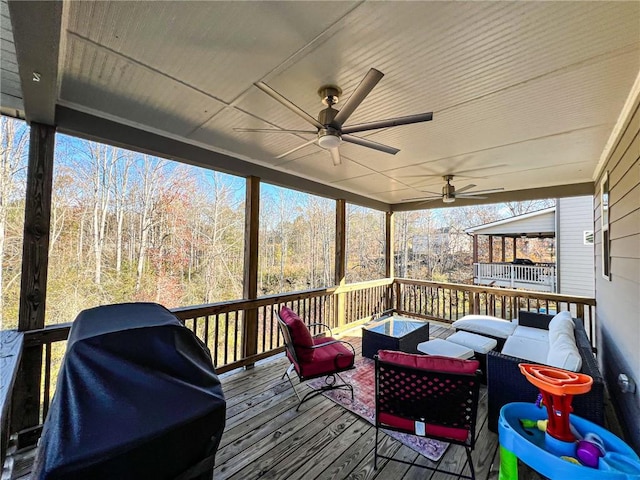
(11, 122, 56, 431)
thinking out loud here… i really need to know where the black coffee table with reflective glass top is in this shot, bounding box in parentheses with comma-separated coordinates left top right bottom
(362, 315, 429, 358)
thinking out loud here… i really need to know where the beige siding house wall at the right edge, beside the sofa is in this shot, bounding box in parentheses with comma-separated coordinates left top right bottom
(594, 91, 640, 450)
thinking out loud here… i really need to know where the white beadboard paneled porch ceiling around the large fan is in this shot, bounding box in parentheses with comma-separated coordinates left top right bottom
(3, 1, 640, 208)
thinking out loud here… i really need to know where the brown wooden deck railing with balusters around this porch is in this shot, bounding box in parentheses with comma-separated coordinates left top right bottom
(0, 279, 596, 453)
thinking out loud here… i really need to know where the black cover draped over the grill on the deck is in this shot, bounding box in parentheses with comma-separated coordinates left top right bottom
(32, 303, 226, 480)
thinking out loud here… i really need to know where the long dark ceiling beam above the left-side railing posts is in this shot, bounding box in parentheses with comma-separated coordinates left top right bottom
(56, 106, 389, 212)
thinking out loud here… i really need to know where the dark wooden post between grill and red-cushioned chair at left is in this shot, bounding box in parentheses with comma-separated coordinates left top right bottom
(242, 177, 260, 368)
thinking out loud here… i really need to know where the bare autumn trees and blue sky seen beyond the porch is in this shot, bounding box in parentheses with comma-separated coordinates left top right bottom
(0, 116, 549, 328)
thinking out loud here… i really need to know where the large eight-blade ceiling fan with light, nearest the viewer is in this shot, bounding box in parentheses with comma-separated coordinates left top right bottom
(234, 68, 433, 165)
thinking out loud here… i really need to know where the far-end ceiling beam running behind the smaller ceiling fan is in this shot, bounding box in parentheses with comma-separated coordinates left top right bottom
(391, 182, 595, 212)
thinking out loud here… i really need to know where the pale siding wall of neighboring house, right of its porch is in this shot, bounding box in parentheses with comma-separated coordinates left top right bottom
(556, 195, 595, 297)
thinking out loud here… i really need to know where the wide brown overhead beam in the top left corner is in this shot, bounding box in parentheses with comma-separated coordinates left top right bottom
(8, 0, 62, 125)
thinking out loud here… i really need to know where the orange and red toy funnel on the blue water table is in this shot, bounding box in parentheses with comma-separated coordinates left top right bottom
(519, 363, 593, 442)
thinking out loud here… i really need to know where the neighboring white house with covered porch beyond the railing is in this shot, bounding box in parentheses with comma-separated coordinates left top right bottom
(465, 196, 595, 297)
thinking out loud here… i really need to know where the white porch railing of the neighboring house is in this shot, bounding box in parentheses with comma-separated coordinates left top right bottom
(473, 262, 557, 293)
